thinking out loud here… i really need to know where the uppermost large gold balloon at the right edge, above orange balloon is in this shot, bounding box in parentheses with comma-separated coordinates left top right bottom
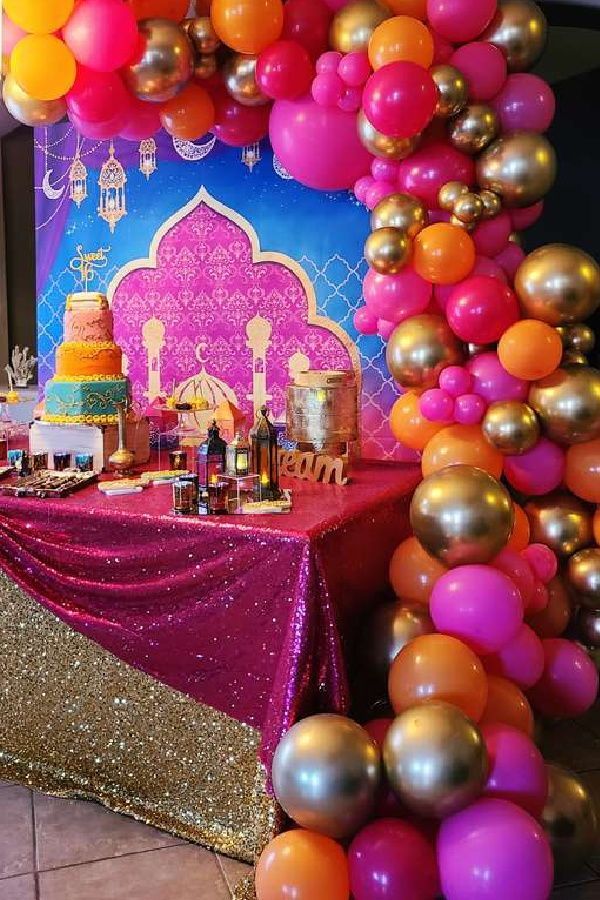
(515, 244, 600, 325)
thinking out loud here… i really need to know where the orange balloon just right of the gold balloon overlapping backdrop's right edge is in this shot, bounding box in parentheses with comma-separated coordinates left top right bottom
(413, 222, 475, 284)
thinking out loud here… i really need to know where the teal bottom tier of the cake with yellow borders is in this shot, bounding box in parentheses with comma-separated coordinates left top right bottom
(43, 377, 128, 425)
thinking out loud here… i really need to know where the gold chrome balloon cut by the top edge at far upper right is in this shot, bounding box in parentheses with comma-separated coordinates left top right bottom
(479, 0, 548, 72)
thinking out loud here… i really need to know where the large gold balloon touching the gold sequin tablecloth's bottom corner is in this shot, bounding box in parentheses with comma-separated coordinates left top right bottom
(273, 714, 381, 840)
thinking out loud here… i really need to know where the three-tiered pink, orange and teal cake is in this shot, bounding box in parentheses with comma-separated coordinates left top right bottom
(43, 294, 128, 425)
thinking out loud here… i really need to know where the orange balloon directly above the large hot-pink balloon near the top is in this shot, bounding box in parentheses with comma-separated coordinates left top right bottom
(369, 16, 434, 69)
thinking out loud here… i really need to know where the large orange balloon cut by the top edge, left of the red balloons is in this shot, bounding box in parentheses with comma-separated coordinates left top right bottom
(210, 0, 283, 53)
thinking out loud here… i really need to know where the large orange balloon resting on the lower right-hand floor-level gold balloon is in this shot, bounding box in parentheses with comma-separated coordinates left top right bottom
(388, 634, 488, 722)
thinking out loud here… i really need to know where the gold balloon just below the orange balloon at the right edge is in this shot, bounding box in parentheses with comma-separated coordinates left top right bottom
(525, 493, 594, 557)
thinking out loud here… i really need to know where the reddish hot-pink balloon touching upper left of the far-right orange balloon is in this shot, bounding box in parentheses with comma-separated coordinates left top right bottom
(446, 275, 520, 344)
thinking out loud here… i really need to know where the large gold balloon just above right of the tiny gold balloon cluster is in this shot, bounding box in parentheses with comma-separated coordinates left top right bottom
(478, 131, 556, 207)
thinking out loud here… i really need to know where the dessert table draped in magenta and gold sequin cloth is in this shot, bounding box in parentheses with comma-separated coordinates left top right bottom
(0, 463, 419, 861)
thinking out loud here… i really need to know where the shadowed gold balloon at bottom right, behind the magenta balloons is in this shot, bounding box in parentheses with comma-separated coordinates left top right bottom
(542, 765, 598, 875)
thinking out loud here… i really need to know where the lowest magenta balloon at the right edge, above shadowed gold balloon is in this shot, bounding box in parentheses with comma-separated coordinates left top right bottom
(528, 638, 598, 718)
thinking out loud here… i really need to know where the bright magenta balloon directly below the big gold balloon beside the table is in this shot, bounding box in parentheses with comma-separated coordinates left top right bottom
(429, 565, 523, 654)
